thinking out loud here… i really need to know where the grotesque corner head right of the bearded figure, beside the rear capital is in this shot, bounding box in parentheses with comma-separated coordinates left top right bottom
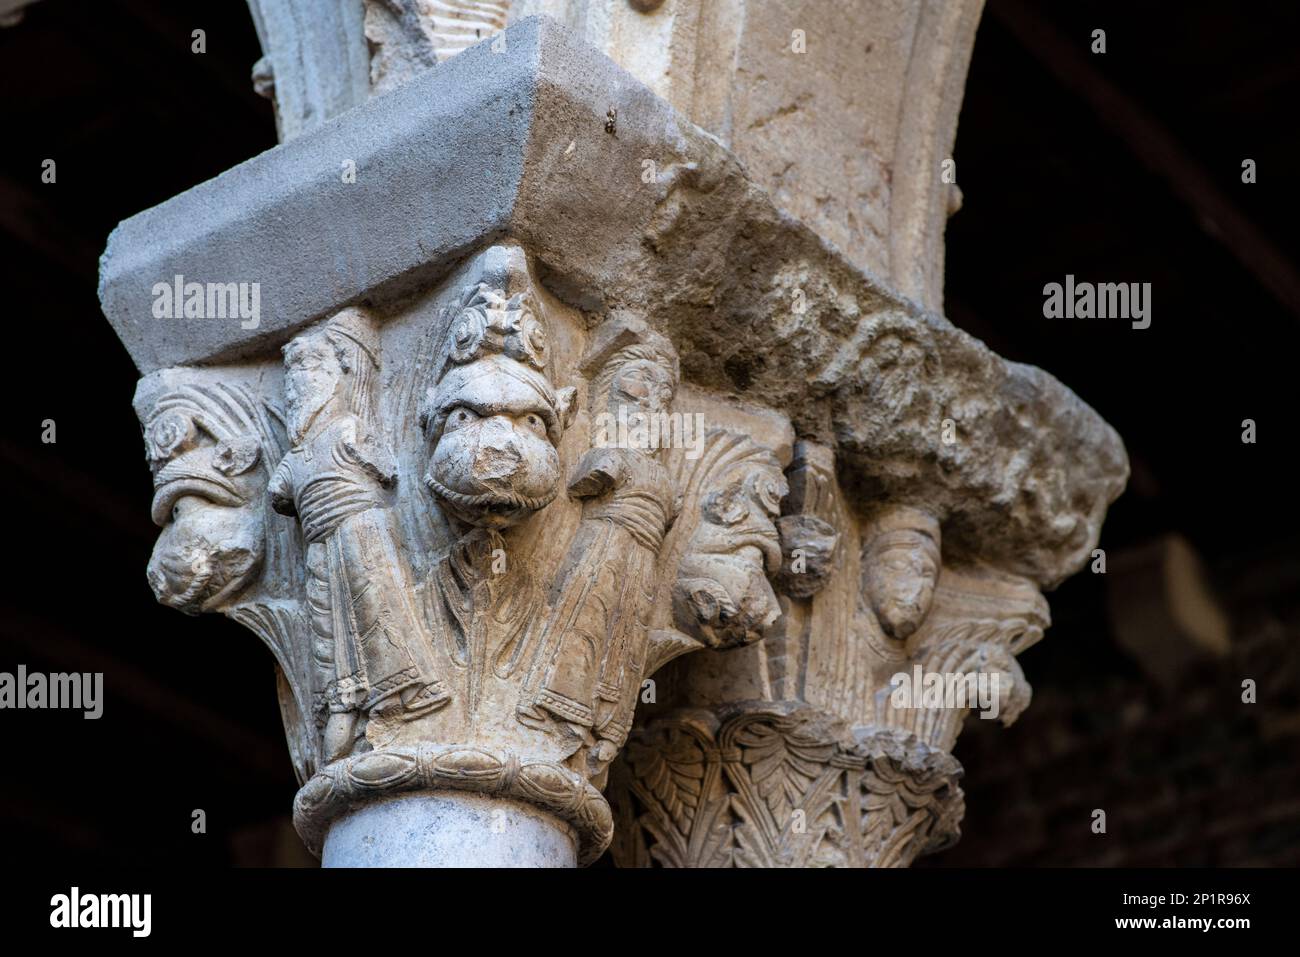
(672, 436, 788, 648)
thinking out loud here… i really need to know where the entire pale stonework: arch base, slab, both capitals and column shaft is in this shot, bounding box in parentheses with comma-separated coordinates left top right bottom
(100, 7, 1127, 866)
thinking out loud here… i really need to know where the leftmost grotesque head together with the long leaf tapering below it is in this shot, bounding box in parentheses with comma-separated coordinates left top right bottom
(137, 371, 320, 781)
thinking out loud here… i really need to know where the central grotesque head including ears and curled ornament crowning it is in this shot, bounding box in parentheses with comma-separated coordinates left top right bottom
(420, 276, 575, 528)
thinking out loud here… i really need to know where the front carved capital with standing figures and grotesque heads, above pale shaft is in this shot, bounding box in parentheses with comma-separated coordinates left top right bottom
(142, 244, 787, 859)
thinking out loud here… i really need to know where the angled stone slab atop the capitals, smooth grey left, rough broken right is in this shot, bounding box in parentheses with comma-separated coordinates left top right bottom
(101, 20, 1127, 588)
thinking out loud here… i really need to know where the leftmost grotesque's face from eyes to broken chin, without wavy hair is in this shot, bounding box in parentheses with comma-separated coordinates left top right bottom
(147, 442, 265, 615)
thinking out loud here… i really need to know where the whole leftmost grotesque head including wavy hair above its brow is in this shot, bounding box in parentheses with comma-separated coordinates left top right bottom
(144, 384, 283, 614)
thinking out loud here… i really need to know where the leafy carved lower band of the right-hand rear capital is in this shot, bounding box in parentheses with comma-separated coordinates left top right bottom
(611, 705, 963, 867)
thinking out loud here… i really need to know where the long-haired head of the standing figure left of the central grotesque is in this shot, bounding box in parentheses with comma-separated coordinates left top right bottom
(283, 307, 380, 443)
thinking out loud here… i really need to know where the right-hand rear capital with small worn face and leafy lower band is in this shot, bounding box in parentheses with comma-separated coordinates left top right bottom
(611, 441, 1049, 867)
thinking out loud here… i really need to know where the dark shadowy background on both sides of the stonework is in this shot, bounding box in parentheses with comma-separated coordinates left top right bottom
(0, 0, 1300, 867)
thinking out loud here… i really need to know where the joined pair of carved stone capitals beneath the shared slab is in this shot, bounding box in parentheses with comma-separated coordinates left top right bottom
(138, 243, 1086, 866)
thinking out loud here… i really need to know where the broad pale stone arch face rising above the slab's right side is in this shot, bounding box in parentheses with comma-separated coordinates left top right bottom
(511, 0, 984, 309)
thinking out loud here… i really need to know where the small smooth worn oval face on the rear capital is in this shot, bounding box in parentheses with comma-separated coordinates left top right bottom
(866, 529, 939, 640)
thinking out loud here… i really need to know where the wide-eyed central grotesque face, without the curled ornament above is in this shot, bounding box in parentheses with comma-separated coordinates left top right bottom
(425, 356, 560, 528)
